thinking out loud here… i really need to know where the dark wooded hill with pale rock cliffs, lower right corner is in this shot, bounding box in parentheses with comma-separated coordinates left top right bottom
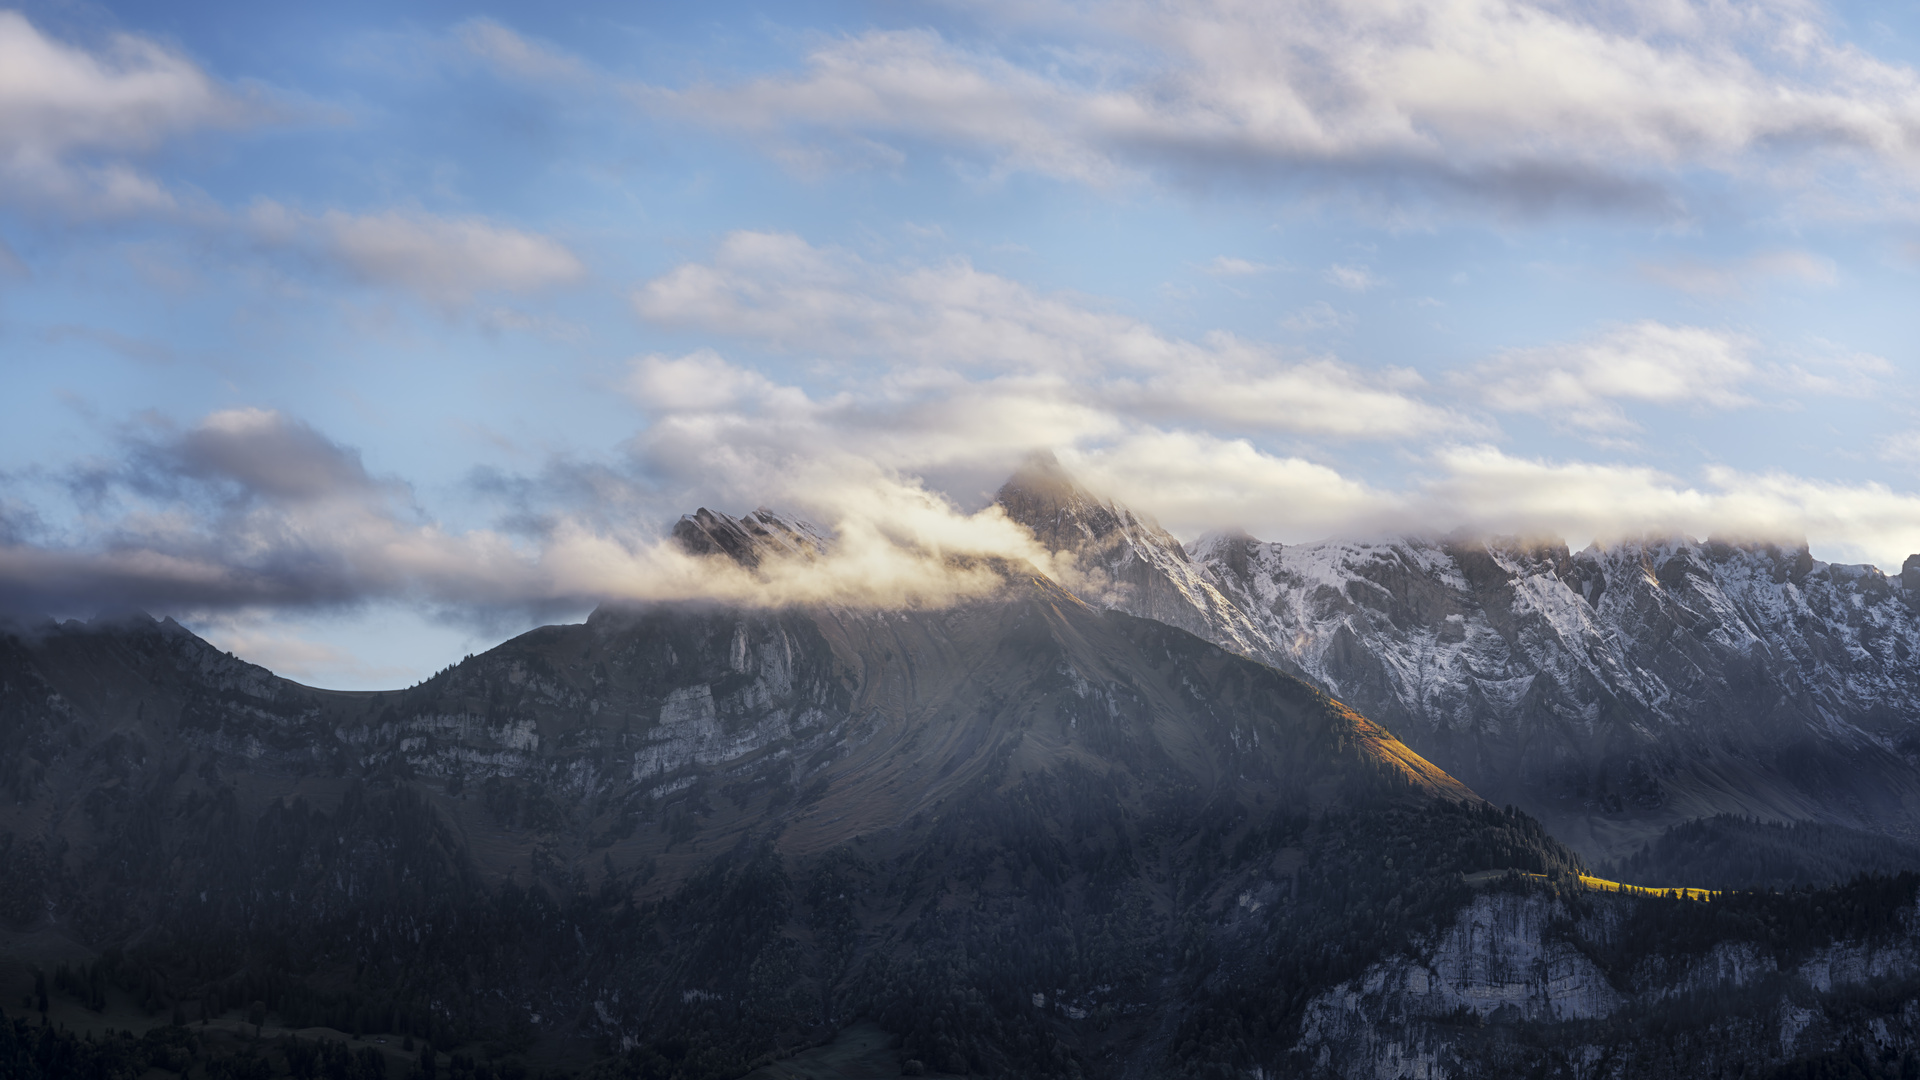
(1283, 876, 1920, 1080)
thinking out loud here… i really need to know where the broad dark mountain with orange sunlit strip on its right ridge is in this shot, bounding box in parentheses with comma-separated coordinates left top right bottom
(0, 534, 1574, 1076)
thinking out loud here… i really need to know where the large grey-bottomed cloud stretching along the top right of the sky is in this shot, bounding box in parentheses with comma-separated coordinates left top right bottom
(634, 0, 1920, 213)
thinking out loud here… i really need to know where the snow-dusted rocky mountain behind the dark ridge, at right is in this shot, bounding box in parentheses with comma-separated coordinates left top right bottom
(998, 459, 1920, 859)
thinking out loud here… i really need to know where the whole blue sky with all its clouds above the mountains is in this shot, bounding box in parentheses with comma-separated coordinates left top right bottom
(0, 0, 1920, 688)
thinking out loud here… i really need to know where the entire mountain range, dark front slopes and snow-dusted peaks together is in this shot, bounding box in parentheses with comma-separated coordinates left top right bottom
(0, 461, 1920, 1080)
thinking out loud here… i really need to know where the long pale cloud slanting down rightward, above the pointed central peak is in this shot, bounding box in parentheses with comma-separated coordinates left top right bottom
(634, 233, 1473, 438)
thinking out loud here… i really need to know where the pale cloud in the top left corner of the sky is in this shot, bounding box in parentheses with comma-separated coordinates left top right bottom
(0, 12, 267, 215)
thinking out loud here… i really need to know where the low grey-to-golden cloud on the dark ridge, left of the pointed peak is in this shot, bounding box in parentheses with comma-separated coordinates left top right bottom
(0, 409, 1098, 622)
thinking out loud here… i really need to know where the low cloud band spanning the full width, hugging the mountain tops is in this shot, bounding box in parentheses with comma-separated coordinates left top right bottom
(0, 401, 1920, 615)
